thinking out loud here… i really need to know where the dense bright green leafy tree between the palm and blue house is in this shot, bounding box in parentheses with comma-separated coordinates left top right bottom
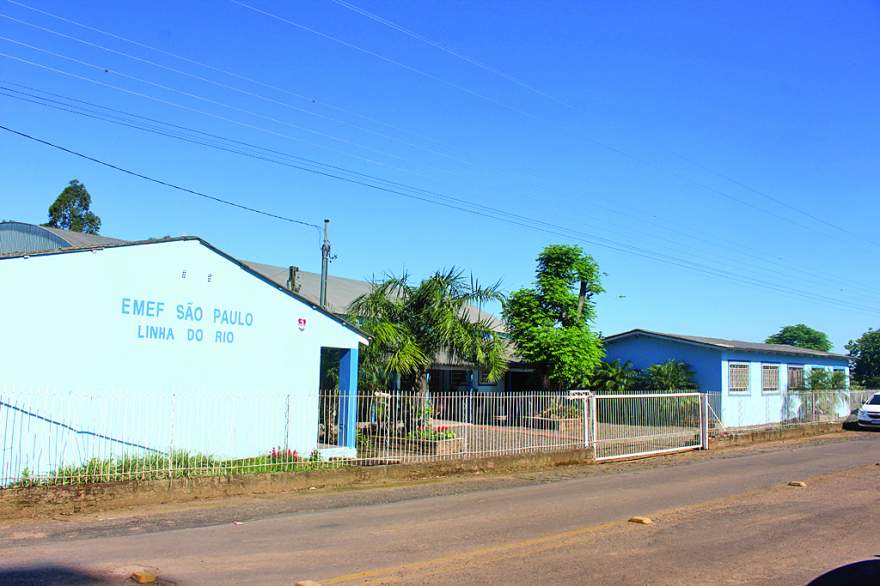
(504, 244, 605, 388)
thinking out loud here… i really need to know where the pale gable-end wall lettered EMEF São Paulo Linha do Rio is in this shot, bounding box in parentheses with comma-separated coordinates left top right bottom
(0, 240, 360, 471)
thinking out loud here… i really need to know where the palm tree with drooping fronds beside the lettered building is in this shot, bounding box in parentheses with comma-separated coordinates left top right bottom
(349, 268, 507, 393)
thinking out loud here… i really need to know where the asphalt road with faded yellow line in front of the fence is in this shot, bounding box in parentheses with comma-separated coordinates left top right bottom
(0, 433, 880, 584)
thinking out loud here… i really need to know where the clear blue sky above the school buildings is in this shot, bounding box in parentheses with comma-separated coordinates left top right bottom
(0, 0, 880, 350)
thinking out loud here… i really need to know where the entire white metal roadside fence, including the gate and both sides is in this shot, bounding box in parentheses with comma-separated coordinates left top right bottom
(0, 389, 874, 488)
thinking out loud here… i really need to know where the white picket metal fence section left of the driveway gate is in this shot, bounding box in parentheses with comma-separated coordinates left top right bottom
(0, 391, 584, 487)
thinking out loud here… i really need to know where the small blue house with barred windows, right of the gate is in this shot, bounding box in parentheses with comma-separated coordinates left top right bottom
(605, 329, 849, 427)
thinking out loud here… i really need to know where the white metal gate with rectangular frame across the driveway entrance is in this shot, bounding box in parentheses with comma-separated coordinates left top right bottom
(574, 392, 709, 461)
